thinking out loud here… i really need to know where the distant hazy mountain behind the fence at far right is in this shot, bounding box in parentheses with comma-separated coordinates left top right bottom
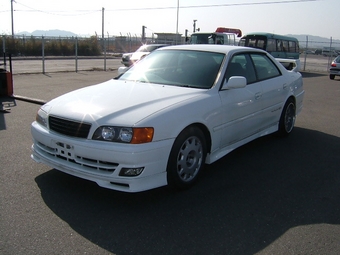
(287, 34, 340, 49)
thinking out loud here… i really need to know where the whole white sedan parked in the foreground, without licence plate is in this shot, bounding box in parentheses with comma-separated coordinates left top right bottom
(31, 45, 304, 192)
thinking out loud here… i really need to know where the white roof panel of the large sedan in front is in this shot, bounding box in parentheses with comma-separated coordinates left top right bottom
(157, 44, 267, 54)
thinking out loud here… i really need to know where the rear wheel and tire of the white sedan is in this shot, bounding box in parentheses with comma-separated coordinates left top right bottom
(278, 98, 296, 136)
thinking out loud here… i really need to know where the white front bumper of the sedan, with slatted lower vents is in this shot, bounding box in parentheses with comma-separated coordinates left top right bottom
(31, 122, 174, 192)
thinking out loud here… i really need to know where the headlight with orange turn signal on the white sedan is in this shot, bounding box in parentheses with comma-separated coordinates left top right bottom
(92, 126, 154, 144)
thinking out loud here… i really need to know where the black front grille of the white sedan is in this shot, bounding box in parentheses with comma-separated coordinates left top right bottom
(48, 116, 91, 138)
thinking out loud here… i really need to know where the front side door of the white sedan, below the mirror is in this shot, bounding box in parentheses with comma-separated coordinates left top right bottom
(220, 53, 262, 148)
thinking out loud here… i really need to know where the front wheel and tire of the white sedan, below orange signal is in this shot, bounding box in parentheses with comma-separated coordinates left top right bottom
(167, 126, 207, 189)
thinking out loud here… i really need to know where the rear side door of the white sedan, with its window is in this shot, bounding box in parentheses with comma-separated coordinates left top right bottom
(250, 53, 289, 130)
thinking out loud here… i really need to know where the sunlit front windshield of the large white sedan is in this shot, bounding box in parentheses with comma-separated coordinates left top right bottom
(119, 50, 225, 89)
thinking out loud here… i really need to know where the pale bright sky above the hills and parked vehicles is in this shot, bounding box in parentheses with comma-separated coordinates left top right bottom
(0, 0, 340, 40)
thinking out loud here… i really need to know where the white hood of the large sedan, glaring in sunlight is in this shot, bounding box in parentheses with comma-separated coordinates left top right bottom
(42, 79, 206, 126)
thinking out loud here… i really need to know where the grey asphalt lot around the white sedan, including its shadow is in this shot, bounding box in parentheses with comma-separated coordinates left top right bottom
(0, 72, 340, 255)
